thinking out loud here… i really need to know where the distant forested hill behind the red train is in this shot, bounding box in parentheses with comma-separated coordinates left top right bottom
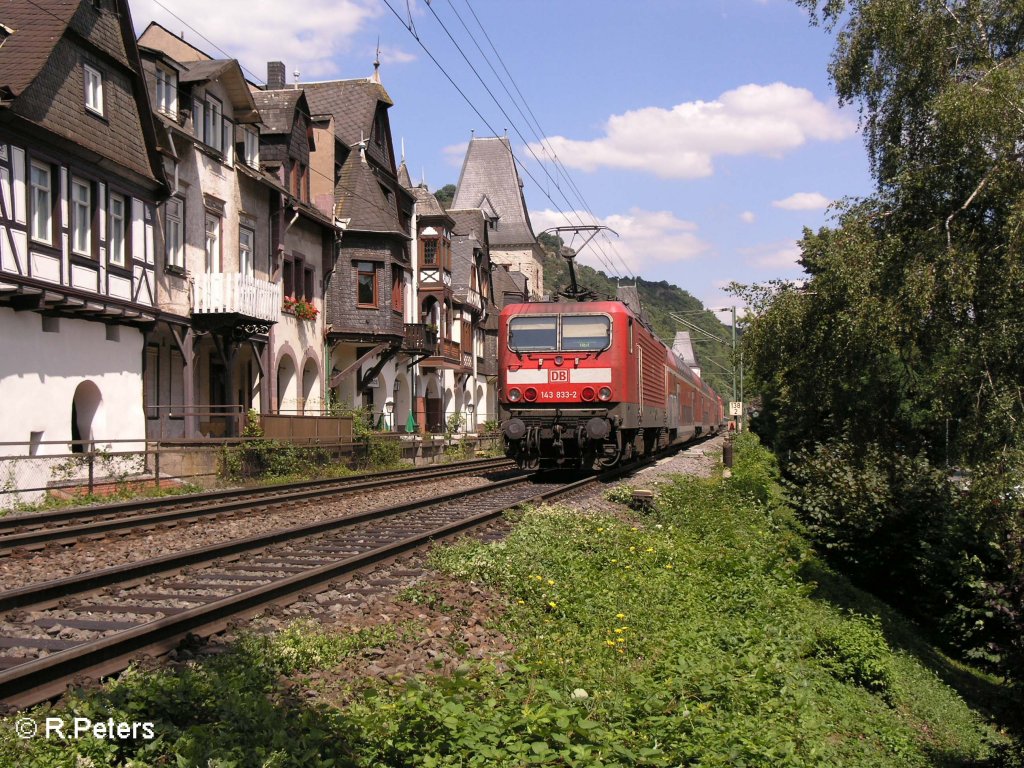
(544, 249, 738, 402)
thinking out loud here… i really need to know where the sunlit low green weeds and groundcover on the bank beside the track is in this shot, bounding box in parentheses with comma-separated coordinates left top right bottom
(0, 435, 1011, 768)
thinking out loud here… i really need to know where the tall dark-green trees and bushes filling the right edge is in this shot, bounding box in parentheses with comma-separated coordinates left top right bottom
(736, 0, 1024, 681)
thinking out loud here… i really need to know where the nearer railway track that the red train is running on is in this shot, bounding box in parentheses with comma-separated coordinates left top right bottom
(0, 465, 638, 708)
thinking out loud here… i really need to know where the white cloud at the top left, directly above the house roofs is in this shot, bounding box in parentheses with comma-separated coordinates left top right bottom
(131, 0, 385, 82)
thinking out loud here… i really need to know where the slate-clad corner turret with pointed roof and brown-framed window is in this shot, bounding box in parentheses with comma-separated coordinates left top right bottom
(302, 73, 422, 427)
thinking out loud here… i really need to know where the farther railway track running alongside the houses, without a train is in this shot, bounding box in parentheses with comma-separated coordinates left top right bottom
(0, 459, 514, 557)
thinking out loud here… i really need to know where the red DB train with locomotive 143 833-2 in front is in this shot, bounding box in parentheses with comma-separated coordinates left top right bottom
(498, 301, 724, 468)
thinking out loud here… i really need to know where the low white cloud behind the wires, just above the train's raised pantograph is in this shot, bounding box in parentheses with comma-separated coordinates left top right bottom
(529, 208, 711, 276)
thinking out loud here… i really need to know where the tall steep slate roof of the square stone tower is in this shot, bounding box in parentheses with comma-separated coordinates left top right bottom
(452, 137, 536, 246)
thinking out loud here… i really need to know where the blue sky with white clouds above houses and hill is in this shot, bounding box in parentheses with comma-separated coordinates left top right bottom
(131, 0, 871, 317)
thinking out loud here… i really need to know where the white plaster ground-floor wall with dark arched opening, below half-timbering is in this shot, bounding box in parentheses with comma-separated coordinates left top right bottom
(0, 309, 145, 456)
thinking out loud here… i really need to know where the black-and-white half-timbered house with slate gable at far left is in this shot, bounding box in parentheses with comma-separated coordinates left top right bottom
(0, 0, 167, 487)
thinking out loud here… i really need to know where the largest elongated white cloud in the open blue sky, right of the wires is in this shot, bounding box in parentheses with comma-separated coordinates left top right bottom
(531, 83, 856, 178)
